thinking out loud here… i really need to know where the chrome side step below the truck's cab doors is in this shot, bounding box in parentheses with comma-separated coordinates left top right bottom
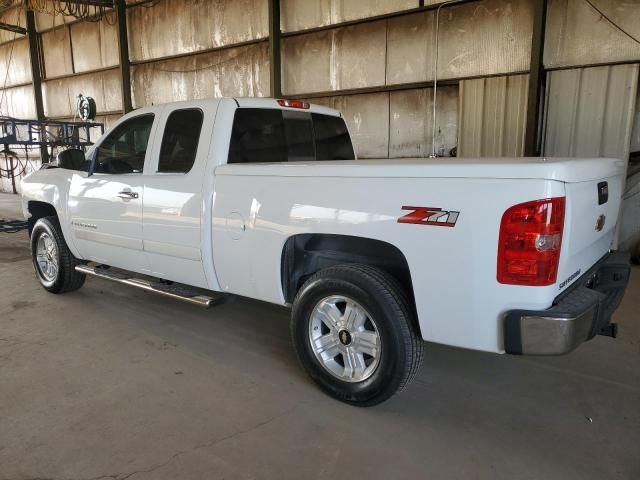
(76, 265, 221, 308)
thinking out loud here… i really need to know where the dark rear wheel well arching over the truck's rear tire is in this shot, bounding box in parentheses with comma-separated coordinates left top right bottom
(281, 234, 415, 320)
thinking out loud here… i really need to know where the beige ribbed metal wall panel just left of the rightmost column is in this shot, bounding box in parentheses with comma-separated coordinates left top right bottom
(458, 75, 529, 157)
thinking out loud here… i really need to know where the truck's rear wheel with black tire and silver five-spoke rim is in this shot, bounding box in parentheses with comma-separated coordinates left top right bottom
(291, 265, 423, 406)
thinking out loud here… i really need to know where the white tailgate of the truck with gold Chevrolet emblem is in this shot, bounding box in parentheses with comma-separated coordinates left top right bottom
(558, 174, 624, 290)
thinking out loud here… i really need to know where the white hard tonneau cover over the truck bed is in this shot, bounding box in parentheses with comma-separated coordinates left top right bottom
(216, 157, 625, 183)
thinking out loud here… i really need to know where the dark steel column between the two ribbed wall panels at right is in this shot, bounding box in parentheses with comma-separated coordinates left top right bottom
(524, 0, 547, 156)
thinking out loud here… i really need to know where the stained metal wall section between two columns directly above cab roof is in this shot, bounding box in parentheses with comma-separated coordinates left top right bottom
(127, 0, 269, 107)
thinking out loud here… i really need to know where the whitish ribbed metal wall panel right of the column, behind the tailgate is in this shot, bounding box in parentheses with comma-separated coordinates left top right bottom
(544, 65, 638, 159)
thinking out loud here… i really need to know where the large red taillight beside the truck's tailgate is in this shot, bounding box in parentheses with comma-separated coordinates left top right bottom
(498, 197, 565, 286)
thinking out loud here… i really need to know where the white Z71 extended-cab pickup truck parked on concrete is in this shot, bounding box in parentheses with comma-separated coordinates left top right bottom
(22, 98, 629, 405)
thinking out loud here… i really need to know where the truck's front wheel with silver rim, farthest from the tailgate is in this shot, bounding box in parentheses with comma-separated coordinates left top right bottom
(31, 217, 86, 293)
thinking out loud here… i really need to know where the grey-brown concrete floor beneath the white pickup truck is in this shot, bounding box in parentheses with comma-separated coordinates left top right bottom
(0, 195, 640, 480)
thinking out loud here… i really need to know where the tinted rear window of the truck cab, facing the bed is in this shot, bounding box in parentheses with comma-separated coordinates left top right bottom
(228, 108, 355, 163)
